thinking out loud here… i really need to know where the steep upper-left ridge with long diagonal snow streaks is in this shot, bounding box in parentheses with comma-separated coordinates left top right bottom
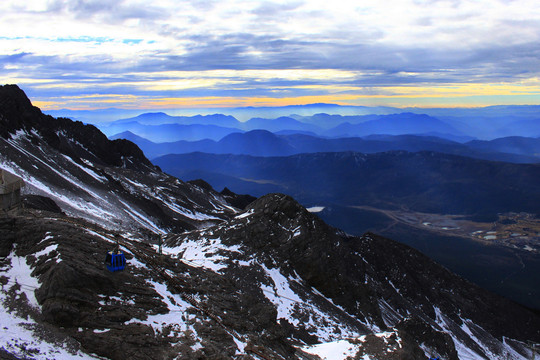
(0, 86, 236, 234)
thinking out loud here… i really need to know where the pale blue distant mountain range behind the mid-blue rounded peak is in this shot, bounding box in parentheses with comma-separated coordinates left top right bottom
(100, 113, 465, 142)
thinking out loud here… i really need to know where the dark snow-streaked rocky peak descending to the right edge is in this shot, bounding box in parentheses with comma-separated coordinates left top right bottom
(165, 194, 540, 359)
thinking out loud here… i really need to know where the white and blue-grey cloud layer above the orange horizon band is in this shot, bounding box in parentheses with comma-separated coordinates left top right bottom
(0, 0, 540, 107)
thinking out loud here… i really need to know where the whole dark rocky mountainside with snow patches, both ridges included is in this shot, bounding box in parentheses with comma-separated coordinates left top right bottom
(0, 87, 540, 359)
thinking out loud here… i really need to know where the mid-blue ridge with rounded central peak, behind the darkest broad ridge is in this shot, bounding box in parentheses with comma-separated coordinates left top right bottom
(110, 130, 540, 163)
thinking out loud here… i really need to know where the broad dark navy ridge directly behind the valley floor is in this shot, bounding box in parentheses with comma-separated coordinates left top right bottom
(153, 151, 540, 215)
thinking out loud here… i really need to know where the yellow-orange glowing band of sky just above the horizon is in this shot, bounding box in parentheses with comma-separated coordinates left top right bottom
(34, 79, 540, 110)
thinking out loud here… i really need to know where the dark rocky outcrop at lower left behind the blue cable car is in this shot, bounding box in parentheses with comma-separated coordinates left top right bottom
(0, 213, 294, 359)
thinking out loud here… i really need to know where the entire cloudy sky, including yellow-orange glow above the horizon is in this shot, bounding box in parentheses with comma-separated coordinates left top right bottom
(0, 0, 540, 109)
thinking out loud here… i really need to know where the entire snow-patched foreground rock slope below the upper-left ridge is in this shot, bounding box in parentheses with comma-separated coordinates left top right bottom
(0, 195, 538, 359)
